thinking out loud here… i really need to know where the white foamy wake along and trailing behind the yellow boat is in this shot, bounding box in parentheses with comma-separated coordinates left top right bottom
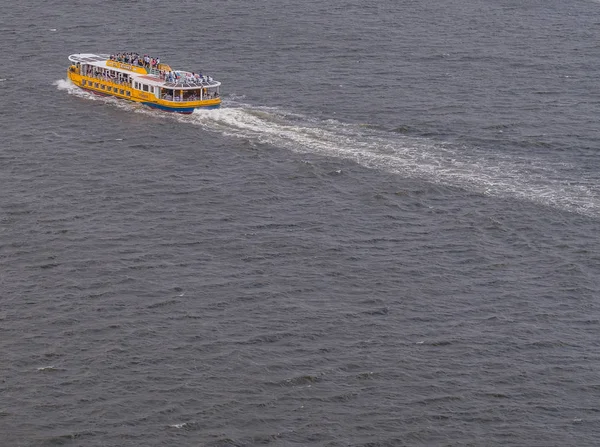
(56, 81, 600, 217)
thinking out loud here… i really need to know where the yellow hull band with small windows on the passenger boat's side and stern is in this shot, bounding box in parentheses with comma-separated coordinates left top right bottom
(67, 69, 221, 113)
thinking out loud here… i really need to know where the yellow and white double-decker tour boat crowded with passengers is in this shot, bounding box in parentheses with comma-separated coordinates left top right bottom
(67, 53, 221, 113)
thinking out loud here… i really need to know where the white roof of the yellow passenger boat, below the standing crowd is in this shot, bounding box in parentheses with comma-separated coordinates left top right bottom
(69, 53, 221, 90)
